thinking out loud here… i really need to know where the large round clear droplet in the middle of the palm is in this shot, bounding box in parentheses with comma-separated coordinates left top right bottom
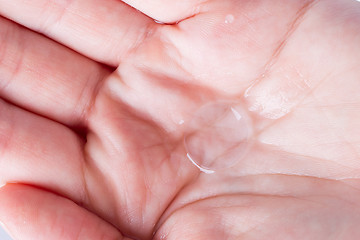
(184, 102, 252, 173)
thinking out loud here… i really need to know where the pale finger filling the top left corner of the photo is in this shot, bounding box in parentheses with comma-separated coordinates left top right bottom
(0, 0, 155, 66)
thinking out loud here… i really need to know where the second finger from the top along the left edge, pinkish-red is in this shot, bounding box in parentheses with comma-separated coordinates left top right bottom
(0, 17, 109, 125)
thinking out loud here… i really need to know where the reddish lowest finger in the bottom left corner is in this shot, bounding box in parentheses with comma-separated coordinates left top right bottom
(0, 184, 124, 240)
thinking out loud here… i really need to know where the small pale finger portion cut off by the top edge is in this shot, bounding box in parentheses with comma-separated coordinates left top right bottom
(123, 0, 209, 23)
